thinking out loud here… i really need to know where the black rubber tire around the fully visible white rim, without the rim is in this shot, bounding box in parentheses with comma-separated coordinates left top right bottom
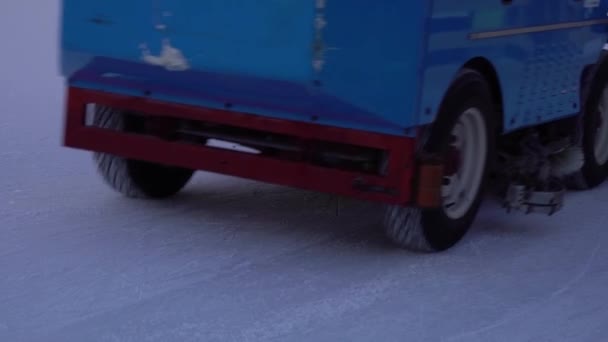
(384, 69, 497, 252)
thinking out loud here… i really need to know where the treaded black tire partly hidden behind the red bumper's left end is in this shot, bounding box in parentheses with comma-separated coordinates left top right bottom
(93, 107, 194, 199)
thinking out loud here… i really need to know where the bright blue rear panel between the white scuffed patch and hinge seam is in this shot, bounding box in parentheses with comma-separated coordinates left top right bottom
(156, 0, 314, 82)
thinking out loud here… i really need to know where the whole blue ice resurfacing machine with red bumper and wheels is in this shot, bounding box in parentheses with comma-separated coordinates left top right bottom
(61, 0, 608, 251)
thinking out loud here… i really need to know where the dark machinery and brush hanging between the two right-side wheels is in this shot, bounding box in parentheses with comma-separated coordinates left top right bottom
(494, 120, 584, 215)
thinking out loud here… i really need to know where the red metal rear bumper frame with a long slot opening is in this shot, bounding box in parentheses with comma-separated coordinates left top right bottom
(65, 88, 417, 205)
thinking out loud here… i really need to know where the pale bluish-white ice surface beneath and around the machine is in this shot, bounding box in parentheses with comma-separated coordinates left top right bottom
(0, 0, 608, 342)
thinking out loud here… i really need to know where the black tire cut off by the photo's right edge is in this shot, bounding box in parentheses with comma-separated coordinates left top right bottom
(568, 60, 608, 190)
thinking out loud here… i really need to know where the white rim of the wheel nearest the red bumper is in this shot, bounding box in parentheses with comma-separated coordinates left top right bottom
(441, 108, 488, 220)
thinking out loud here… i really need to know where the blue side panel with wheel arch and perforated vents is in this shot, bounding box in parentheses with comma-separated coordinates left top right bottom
(418, 0, 607, 131)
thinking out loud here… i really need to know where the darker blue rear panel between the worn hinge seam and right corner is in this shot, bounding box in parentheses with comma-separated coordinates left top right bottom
(319, 0, 430, 127)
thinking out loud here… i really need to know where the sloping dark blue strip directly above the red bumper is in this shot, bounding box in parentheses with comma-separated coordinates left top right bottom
(69, 58, 404, 136)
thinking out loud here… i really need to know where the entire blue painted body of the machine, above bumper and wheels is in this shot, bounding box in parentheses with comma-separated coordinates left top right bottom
(61, 0, 608, 136)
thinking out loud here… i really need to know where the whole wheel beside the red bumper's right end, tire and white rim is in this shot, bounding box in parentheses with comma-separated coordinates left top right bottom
(384, 69, 496, 252)
